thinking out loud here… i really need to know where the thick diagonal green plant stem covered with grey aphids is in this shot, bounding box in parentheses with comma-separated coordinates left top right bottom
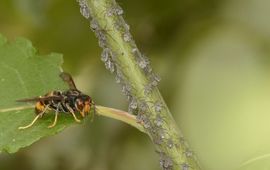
(79, 0, 200, 170)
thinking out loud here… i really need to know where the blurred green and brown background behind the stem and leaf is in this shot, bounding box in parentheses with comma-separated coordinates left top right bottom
(0, 0, 270, 170)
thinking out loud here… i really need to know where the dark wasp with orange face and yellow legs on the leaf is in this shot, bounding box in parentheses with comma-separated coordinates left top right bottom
(17, 72, 95, 129)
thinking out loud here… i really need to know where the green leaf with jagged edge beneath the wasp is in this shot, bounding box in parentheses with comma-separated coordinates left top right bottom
(0, 35, 77, 153)
